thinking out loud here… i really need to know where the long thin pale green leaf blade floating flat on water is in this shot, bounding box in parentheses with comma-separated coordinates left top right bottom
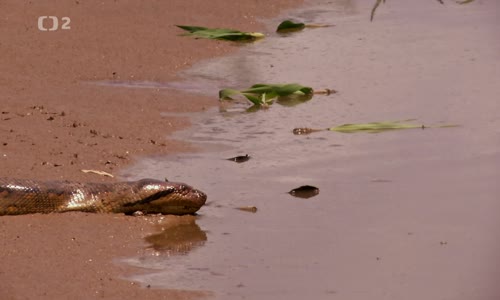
(293, 120, 458, 135)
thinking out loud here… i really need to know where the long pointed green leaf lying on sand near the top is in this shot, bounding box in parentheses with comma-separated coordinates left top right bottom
(175, 25, 264, 41)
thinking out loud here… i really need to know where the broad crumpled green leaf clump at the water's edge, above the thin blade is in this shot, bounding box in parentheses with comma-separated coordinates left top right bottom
(219, 83, 335, 108)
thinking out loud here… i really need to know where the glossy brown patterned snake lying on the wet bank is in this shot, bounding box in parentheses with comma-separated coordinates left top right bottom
(0, 178, 207, 215)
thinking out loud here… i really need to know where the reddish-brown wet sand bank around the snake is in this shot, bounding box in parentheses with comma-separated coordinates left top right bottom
(0, 0, 301, 299)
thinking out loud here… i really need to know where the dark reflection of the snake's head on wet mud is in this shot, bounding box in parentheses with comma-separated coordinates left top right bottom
(145, 215, 207, 255)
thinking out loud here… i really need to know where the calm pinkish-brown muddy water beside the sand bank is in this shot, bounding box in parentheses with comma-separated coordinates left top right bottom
(122, 0, 500, 300)
